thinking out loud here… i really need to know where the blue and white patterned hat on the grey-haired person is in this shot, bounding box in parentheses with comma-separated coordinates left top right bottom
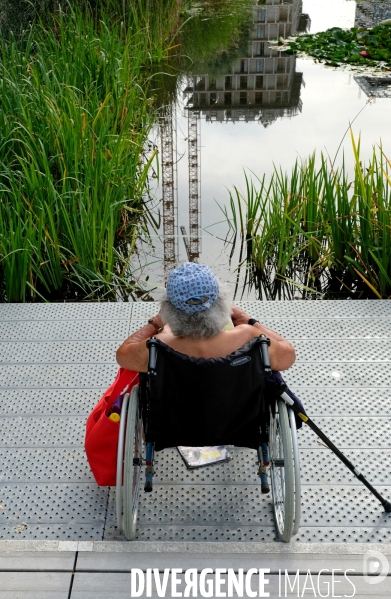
(167, 262, 219, 314)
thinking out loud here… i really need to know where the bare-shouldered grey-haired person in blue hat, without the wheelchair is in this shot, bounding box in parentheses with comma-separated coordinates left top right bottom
(117, 262, 296, 372)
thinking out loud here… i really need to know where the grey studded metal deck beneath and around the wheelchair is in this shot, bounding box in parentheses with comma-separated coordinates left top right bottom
(0, 301, 391, 543)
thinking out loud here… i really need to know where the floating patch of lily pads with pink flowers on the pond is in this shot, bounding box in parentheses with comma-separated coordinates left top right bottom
(279, 23, 391, 68)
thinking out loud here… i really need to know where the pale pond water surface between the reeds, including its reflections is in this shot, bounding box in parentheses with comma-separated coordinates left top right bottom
(133, 0, 391, 300)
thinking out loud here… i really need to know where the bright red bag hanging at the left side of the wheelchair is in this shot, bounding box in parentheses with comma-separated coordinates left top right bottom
(84, 368, 139, 487)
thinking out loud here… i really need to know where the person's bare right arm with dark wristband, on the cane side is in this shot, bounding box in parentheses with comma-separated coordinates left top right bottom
(231, 305, 296, 370)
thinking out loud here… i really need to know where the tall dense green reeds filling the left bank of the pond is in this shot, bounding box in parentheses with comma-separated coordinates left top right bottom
(0, 0, 181, 301)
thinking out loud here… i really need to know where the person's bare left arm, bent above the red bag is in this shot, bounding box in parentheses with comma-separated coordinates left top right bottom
(116, 314, 163, 372)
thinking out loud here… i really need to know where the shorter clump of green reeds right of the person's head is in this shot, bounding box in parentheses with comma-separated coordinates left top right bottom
(225, 135, 391, 299)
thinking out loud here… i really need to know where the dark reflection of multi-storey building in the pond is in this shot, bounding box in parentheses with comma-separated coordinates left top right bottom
(185, 0, 309, 127)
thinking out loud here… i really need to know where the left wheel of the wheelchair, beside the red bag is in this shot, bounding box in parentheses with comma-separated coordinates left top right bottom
(117, 386, 143, 541)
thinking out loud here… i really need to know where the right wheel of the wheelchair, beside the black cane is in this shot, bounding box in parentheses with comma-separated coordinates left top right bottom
(269, 399, 295, 543)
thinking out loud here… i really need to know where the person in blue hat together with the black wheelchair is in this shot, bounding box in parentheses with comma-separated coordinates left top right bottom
(116, 262, 300, 542)
